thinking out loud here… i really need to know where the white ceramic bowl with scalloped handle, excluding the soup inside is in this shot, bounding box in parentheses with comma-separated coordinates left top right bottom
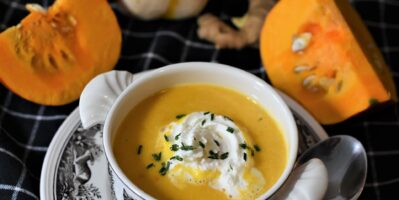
(79, 62, 298, 199)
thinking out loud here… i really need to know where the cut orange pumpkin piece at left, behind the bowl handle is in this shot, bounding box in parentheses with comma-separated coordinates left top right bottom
(0, 0, 122, 105)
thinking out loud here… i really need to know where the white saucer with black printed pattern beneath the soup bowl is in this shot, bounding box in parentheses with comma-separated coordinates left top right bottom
(40, 88, 328, 200)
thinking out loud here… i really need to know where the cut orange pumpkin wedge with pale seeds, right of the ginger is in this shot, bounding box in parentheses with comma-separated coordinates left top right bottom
(260, 0, 397, 124)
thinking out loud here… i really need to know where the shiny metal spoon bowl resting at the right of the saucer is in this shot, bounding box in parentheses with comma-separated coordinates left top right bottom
(297, 135, 367, 200)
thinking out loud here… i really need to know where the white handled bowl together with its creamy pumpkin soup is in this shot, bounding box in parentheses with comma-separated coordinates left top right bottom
(79, 62, 298, 200)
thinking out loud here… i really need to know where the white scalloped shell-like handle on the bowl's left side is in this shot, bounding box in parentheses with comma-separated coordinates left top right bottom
(79, 70, 133, 129)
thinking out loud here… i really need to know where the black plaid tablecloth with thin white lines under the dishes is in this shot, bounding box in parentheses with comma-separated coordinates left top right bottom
(0, 0, 399, 200)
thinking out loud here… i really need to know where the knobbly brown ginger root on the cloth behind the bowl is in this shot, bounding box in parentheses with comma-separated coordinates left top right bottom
(198, 0, 274, 49)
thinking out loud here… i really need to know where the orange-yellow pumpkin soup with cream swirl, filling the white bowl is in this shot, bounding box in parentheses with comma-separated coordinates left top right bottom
(113, 84, 287, 200)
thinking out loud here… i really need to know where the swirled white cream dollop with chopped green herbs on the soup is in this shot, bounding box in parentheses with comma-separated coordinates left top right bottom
(161, 112, 265, 199)
